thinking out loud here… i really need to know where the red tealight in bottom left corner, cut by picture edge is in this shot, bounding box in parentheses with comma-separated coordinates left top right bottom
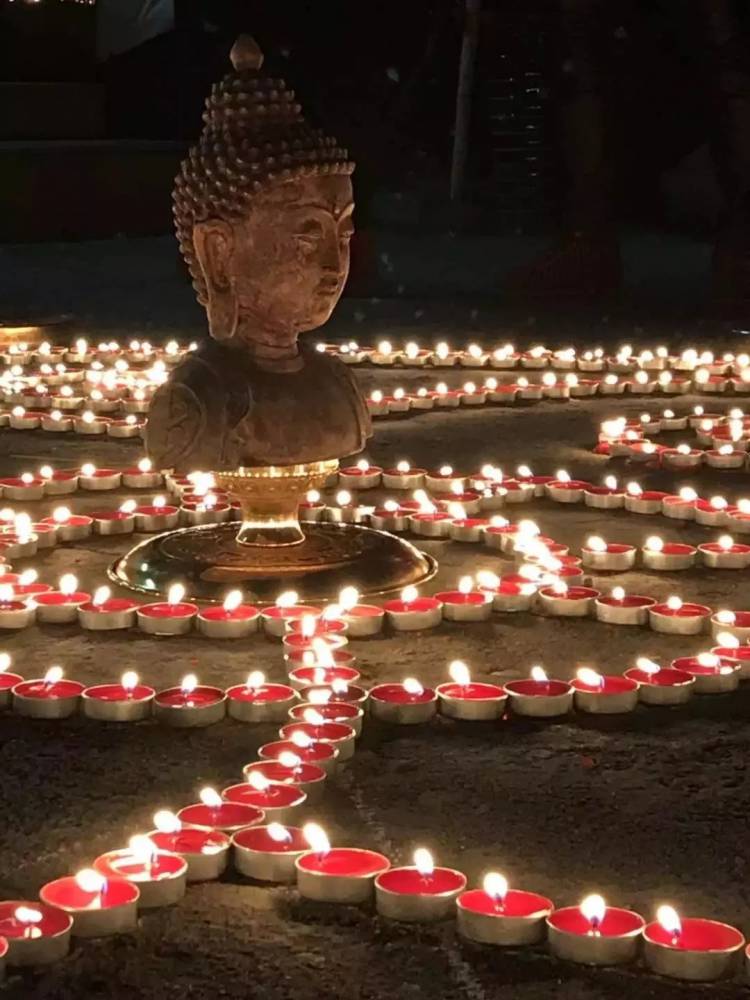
(0, 900, 73, 966)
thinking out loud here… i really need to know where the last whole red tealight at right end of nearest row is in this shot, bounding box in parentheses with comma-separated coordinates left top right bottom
(644, 906, 745, 982)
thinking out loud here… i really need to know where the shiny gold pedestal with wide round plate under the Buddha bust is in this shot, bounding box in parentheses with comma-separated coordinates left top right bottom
(109, 460, 437, 603)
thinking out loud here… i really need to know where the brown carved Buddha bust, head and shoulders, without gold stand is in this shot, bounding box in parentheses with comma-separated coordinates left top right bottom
(146, 36, 371, 472)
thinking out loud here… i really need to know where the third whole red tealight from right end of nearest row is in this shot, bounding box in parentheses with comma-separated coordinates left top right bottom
(456, 872, 554, 947)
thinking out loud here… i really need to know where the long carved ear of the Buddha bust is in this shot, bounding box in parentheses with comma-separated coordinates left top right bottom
(193, 219, 238, 340)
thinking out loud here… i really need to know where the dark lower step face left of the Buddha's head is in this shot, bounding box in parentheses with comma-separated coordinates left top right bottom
(0, 139, 185, 242)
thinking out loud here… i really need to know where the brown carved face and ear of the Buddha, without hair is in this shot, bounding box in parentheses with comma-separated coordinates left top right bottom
(193, 174, 354, 357)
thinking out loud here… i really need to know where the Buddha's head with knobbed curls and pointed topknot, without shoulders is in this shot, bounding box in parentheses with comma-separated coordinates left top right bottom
(173, 35, 354, 364)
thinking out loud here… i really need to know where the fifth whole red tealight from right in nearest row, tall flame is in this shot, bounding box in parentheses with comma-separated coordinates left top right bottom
(295, 823, 390, 905)
